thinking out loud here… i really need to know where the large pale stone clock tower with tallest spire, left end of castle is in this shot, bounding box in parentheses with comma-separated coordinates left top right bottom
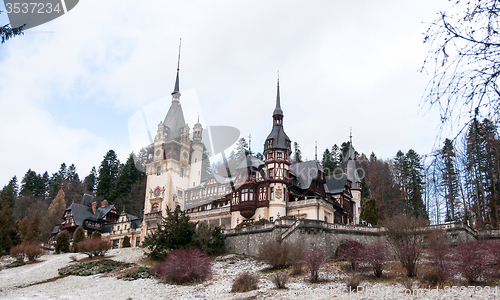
(141, 45, 204, 241)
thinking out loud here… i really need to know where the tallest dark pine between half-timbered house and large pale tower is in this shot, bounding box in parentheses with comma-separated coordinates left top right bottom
(96, 150, 120, 200)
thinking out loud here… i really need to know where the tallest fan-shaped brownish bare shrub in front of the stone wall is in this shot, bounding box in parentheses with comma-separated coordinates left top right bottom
(383, 215, 429, 277)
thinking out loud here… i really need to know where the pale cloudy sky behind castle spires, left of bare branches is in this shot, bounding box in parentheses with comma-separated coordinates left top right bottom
(0, 0, 458, 187)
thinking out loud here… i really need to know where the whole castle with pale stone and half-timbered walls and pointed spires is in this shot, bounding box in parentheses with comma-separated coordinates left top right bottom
(141, 59, 361, 240)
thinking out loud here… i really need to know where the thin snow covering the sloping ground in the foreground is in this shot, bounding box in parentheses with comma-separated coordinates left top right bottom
(0, 248, 500, 300)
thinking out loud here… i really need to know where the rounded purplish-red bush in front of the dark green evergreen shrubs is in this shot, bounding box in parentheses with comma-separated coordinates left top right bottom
(151, 248, 212, 284)
